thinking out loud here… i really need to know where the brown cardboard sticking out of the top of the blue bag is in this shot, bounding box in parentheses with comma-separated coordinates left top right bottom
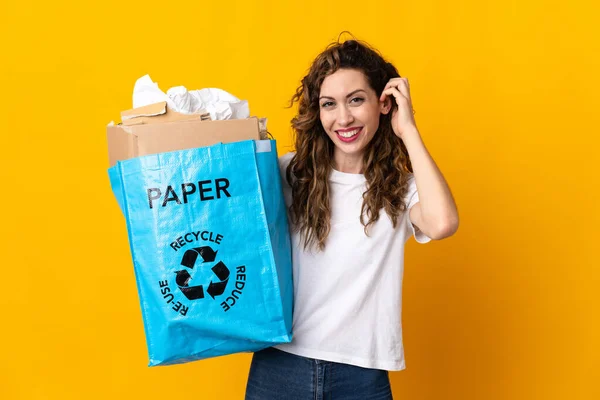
(106, 102, 264, 167)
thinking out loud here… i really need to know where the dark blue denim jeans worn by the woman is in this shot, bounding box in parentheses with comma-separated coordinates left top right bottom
(246, 347, 392, 400)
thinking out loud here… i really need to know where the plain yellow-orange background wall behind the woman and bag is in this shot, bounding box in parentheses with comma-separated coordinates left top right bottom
(0, 0, 600, 400)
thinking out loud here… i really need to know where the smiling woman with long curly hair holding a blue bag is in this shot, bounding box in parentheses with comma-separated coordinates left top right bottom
(246, 40, 458, 400)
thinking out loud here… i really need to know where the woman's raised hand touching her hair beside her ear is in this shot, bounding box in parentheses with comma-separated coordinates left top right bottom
(379, 78, 418, 139)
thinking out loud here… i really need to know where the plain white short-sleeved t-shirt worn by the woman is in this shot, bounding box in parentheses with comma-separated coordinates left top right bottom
(274, 153, 431, 371)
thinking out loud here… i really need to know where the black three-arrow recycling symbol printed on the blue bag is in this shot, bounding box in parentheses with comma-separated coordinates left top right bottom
(175, 246, 229, 300)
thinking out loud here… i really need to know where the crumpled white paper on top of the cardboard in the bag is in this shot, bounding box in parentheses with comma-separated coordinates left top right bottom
(133, 75, 250, 120)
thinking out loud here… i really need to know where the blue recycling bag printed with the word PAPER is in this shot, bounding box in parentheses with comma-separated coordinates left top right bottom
(108, 140, 293, 366)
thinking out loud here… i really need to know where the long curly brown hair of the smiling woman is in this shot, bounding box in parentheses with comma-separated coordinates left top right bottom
(286, 40, 412, 250)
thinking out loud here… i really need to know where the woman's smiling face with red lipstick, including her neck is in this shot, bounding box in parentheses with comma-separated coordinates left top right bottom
(319, 69, 388, 173)
